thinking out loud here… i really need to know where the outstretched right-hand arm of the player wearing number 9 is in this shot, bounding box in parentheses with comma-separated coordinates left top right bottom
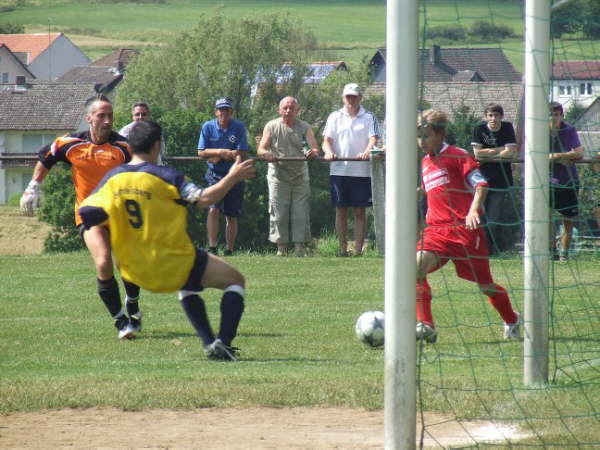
(183, 156, 256, 208)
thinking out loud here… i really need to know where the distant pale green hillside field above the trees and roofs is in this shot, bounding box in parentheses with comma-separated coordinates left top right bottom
(0, 0, 600, 72)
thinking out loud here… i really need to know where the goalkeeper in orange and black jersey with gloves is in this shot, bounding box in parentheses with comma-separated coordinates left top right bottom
(21, 96, 142, 339)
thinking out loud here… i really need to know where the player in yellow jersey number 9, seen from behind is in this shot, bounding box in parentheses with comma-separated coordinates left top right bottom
(79, 121, 256, 361)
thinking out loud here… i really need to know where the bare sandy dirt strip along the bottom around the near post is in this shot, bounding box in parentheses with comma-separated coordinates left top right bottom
(0, 407, 527, 449)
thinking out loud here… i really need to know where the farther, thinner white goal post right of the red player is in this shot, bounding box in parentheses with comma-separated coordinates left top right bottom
(523, 0, 550, 386)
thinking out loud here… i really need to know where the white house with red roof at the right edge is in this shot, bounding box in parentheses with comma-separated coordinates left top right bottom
(552, 61, 600, 109)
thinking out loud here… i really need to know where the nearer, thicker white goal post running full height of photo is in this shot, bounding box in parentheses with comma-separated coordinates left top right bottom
(384, 0, 419, 449)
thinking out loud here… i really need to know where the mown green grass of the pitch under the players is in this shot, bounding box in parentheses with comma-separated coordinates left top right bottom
(0, 250, 600, 445)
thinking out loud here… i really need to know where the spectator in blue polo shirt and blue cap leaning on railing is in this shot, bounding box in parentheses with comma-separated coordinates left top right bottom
(198, 97, 248, 256)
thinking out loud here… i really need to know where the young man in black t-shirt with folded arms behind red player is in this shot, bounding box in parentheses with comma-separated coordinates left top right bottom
(471, 103, 518, 255)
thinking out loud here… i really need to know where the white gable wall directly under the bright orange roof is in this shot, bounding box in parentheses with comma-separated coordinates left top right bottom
(28, 36, 90, 80)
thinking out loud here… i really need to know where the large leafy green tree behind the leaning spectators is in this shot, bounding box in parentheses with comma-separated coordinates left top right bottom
(115, 12, 367, 249)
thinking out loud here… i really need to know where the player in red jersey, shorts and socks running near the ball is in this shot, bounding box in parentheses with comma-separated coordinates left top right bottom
(417, 110, 520, 343)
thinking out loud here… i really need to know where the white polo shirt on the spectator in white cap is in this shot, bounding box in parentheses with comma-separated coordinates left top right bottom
(323, 106, 379, 177)
